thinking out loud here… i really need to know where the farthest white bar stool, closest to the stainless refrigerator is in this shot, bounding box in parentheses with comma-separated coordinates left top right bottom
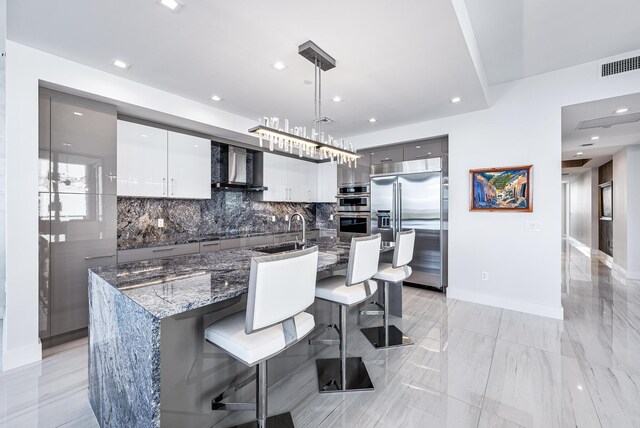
(362, 230, 416, 348)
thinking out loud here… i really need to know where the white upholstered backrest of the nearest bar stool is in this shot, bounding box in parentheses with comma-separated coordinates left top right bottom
(245, 246, 318, 334)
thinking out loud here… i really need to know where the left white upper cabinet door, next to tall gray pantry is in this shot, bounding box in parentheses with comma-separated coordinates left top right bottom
(117, 120, 168, 198)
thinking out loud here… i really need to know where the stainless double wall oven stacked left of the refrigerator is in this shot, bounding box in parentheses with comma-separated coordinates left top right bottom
(336, 183, 371, 237)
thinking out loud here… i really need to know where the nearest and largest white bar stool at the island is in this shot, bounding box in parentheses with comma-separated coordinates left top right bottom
(205, 246, 318, 428)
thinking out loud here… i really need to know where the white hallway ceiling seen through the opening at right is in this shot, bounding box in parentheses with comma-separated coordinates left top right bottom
(562, 93, 640, 172)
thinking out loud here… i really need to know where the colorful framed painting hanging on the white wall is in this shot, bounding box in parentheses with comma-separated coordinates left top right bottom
(469, 165, 533, 212)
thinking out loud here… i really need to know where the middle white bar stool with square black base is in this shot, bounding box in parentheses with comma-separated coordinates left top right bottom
(309, 234, 381, 392)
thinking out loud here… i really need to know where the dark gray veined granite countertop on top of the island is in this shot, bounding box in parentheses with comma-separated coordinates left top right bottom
(91, 238, 393, 318)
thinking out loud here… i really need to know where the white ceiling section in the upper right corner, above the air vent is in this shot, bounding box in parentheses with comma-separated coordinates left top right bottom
(465, 0, 640, 85)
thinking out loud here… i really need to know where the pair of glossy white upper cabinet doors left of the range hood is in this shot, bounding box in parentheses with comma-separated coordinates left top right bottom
(118, 121, 211, 199)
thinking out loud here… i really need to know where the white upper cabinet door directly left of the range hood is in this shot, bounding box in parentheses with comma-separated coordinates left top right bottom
(167, 131, 211, 199)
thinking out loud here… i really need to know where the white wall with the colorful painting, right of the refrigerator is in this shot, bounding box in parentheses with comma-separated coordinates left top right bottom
(349, 50, 640, 318)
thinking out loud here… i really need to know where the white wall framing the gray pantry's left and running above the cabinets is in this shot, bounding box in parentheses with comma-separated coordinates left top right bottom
(2, 41, 254, 370)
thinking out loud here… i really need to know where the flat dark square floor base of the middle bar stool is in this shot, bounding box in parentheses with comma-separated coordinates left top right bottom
(316, 357, 374, 393)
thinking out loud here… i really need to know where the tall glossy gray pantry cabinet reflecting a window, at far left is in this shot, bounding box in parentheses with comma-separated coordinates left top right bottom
(38, 88, 117, 347)
